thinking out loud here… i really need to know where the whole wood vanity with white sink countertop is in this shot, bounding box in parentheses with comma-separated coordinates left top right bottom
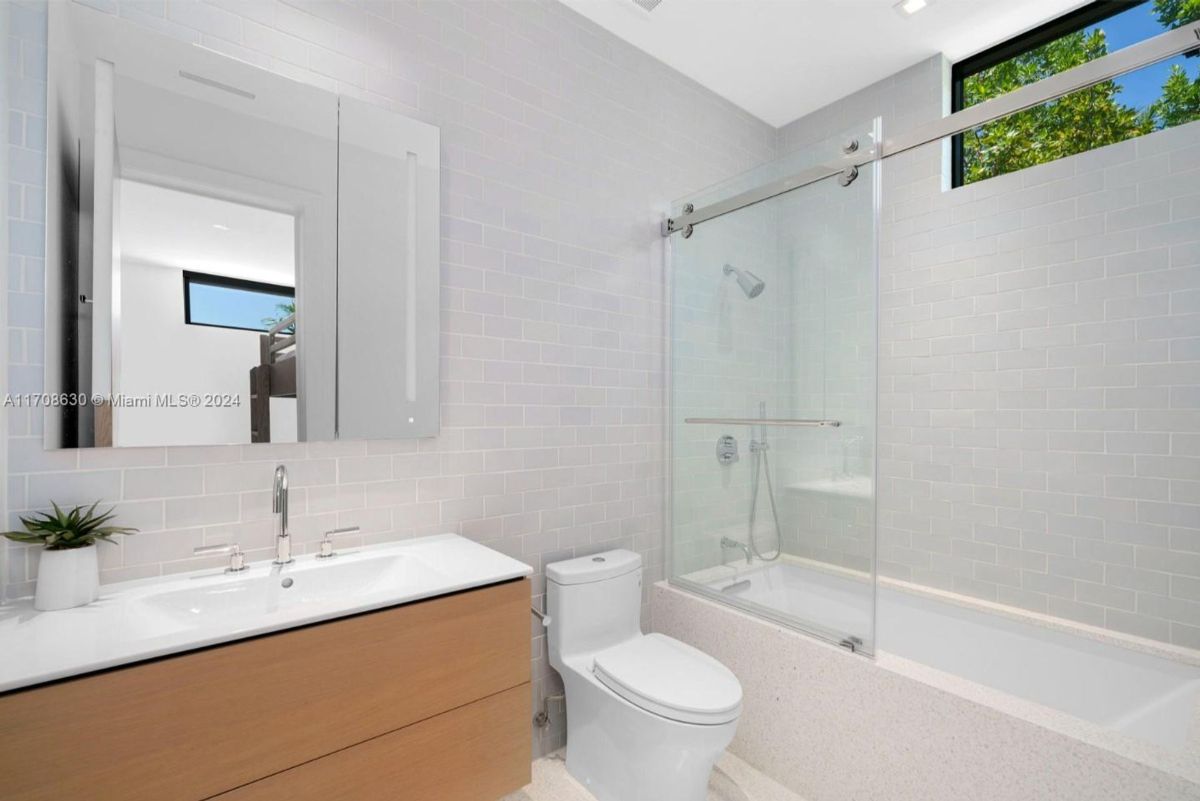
(0, 535, 530, 801)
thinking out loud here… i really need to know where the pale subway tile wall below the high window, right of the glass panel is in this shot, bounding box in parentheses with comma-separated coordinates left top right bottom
(780, 58, 1200, 648)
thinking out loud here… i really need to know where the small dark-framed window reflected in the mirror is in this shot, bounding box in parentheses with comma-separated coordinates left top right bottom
(184, 271, 296, 333)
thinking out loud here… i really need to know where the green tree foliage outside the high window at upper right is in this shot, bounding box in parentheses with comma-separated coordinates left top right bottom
(962, 0, 1200, 183)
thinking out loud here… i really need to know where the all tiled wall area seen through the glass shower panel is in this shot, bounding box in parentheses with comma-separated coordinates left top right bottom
(671, 130, 876, 582)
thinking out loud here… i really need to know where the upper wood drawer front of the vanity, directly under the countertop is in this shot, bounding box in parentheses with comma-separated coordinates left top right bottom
(0, 579, 530, 801)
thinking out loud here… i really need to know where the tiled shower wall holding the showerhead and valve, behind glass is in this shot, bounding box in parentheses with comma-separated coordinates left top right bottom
(671, 188, 787, 573)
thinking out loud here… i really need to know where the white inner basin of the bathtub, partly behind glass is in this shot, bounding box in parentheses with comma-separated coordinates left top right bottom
(704, 564, 1200, 749)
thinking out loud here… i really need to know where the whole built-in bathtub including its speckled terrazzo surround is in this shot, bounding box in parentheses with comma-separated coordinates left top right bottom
(650, 573, 1200, 801)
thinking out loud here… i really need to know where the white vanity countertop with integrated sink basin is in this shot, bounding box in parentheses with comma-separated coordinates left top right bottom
(0, 534, 533, 692)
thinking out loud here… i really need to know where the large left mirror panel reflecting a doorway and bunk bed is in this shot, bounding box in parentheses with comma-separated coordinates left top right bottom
(46, 5, 337, 447)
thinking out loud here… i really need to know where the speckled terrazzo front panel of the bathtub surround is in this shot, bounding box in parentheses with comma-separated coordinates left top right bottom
(650, 583, 1200, 801)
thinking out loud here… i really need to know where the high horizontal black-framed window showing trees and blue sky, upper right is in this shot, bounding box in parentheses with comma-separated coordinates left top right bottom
(952, 0, 1200, 186)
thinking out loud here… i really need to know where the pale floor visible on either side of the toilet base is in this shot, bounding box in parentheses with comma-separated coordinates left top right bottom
(500, 752, 804, 801)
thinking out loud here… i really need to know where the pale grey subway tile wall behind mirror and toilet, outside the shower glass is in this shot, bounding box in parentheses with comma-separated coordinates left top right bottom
(0, 0, 775, 752)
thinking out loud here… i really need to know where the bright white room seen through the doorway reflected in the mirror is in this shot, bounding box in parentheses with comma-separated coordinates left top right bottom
(113, 180, 296, 445)
